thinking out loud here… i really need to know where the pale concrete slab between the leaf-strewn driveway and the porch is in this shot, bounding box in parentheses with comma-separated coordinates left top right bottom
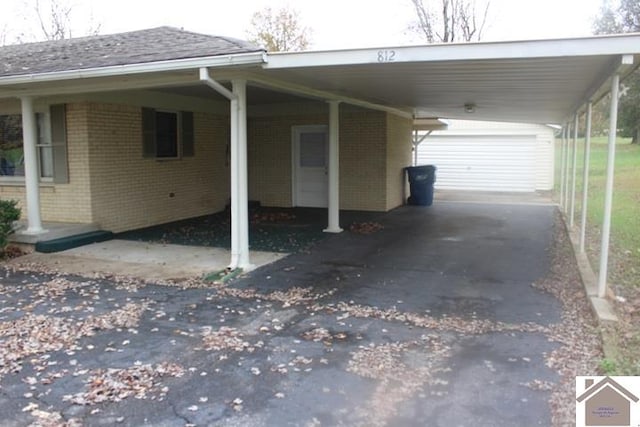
(9, 240, 286, 280)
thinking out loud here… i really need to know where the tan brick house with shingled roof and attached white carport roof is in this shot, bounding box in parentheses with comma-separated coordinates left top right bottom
(0, 27, 640, 267)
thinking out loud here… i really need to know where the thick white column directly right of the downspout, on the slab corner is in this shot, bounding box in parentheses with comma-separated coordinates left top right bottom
(231, 80, 254, 270)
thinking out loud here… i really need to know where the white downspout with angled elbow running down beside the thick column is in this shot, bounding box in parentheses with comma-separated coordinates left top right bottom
(200, 68, 240, 270)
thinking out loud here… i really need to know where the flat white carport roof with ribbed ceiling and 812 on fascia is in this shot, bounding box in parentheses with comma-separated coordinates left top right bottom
(260, 34, 640, 123)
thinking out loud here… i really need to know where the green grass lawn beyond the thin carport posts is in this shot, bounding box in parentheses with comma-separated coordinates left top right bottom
(556, 137, 640, 375)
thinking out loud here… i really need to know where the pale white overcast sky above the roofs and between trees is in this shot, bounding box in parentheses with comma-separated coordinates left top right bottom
(0, 0, 602, 50)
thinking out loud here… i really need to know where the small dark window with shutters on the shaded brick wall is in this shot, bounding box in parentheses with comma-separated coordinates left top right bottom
(142, 108, 194, 159)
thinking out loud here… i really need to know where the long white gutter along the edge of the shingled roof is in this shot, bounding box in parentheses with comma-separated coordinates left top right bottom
(0, 51, 267, 87)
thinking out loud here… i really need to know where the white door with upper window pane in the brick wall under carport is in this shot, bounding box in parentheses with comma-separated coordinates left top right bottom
(293, 126, 329, 208)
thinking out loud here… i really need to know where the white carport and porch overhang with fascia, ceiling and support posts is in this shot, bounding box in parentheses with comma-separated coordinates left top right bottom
(5, 35, 640, 296)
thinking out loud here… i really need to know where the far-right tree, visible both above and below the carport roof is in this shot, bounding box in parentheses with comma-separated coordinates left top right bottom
(594, 0, 640, 144)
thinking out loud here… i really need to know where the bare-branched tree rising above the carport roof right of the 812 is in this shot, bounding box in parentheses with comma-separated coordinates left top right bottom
(411, 0, 490, 43)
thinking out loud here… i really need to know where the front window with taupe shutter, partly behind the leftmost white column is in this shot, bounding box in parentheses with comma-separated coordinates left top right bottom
(0, 105, 68, 183)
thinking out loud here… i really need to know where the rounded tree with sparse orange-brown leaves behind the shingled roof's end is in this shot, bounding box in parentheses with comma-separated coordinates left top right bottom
(247, 7, 311, 52)
